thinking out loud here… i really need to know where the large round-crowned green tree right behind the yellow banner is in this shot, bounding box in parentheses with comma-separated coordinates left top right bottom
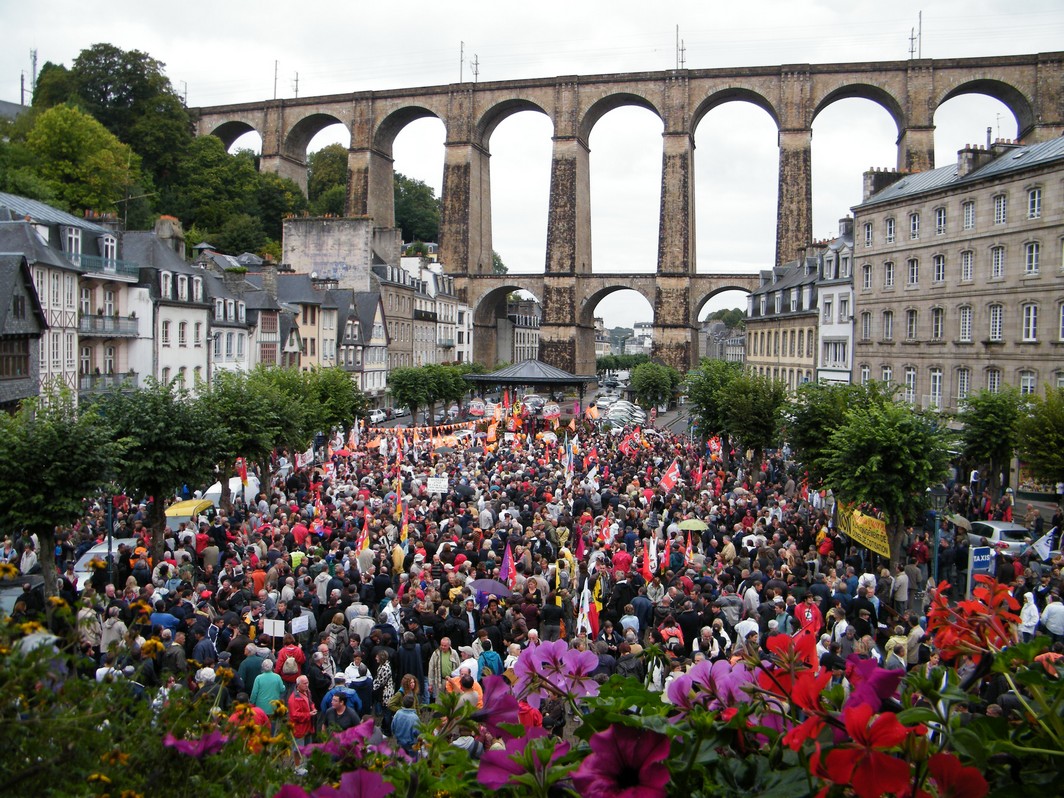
(824, 402, 949, 562)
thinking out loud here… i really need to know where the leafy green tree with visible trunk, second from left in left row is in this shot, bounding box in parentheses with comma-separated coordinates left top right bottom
(98, 380, 225, 563)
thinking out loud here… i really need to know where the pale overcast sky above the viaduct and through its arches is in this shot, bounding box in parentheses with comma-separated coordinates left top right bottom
(0, 0, 1064, 327)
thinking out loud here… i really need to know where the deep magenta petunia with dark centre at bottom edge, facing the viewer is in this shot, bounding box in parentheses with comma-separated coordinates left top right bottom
(572, 725, 669, 798)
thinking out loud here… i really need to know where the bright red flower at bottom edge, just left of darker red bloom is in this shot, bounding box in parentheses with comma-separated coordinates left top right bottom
(812, 705, 914, 798)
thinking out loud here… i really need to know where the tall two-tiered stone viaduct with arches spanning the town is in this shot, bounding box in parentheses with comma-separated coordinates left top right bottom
(196, 52, 1064, 373)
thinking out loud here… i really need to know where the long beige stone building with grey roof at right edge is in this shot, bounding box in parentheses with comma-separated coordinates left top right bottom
(853, 138, 1064, 412)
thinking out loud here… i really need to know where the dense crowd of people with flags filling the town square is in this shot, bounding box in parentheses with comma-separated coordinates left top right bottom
(2, 406, 1064, 752)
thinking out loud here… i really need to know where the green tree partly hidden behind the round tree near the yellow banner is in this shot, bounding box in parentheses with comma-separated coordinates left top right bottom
(782, 382, 896, 485)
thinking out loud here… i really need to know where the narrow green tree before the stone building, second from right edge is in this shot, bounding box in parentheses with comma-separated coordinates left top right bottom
(959, 387, 1023, 497)
